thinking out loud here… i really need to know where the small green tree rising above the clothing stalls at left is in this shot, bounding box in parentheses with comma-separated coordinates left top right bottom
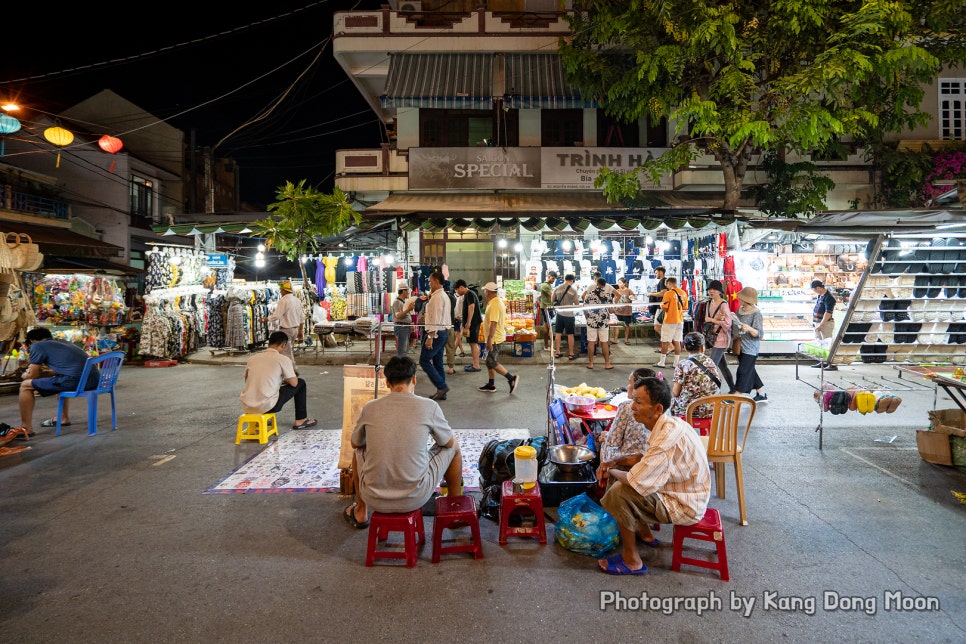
(252, 179, 361, 290)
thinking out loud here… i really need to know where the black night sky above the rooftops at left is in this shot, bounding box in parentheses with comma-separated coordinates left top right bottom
(0, 0, 382, 205)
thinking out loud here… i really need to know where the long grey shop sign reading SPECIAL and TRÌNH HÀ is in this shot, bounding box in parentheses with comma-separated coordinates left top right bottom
(409, 147, 673, 190)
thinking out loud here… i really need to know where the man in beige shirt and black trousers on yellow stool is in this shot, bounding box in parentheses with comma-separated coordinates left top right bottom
(239, 331, 316, 429)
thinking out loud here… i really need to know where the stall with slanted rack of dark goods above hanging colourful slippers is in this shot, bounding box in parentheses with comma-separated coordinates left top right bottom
(752, 210, 966, 449)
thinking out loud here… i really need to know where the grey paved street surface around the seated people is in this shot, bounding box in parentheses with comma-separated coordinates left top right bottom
(0, 345, 966, 642)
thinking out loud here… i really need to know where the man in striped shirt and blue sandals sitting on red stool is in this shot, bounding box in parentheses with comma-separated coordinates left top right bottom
(597, 378, 711, 575)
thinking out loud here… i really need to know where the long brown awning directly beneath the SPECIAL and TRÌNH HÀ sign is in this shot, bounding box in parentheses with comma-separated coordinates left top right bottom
(362, 191, 734, 231)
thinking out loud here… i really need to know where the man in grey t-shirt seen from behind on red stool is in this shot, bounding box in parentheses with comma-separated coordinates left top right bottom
(342, 356, 463, 529)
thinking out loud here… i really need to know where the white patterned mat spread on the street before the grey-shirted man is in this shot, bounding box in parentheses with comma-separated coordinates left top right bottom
(205, 429, 530, 494)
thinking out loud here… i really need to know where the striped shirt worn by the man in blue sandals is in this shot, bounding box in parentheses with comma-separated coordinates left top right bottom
(627, 415, 711, 525)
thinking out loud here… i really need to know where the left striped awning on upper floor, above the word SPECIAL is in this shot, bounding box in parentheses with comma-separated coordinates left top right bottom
(380, 53, 493, 110)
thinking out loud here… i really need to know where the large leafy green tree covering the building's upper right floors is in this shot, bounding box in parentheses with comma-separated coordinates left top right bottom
(560, 0, 964, 210)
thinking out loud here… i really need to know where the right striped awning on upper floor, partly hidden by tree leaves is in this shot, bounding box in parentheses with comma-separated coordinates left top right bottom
(503, 54, 599, 109)
